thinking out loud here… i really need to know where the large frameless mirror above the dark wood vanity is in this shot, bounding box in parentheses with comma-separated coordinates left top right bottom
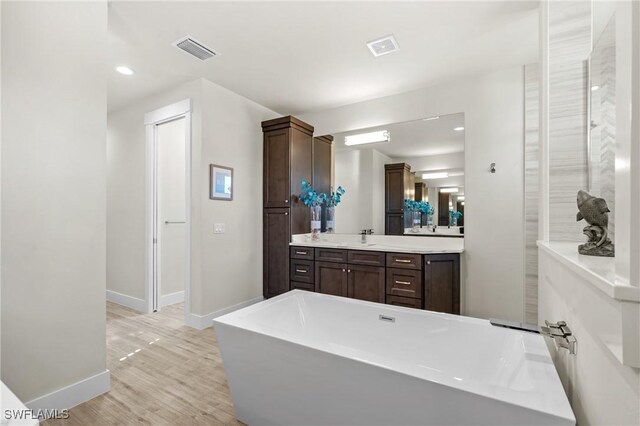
(333, 113, 465, 238)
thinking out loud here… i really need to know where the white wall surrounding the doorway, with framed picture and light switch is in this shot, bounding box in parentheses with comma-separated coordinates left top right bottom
(107, 79, 278, 316)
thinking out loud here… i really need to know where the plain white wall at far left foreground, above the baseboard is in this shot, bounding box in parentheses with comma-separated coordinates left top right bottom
(1, 2, 108, 402)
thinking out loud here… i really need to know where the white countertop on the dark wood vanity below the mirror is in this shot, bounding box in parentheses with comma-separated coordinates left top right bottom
(289, 234, 464, 254)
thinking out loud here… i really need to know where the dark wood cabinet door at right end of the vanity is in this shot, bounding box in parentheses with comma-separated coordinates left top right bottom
(424, 254, 460, 314)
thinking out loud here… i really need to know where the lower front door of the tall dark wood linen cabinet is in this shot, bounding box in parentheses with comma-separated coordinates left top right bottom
(262, 209, 290, 297)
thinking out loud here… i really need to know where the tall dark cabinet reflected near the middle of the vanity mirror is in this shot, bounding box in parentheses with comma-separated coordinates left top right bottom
(384, 163, 415, 235)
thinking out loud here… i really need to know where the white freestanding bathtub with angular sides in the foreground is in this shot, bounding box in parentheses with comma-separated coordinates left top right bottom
(214, 290, 575, 425)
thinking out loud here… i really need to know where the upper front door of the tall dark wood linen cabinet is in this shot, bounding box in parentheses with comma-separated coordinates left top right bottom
(263, 129, 291, 208)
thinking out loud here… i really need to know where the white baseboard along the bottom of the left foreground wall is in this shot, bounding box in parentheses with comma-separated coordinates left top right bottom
(25, 370, 111, 411)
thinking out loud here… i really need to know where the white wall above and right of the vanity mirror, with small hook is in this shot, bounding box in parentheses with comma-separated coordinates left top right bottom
(299, 67, 524, 321)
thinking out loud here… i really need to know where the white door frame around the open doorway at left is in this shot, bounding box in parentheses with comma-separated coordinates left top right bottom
(144, 99, 192, 323)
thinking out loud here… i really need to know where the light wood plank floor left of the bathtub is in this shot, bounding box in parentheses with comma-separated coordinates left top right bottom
(44, 302, 242, 426)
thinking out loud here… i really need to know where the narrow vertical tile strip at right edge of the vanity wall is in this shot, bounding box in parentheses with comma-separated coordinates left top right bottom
(524, 64, 540, 324)
